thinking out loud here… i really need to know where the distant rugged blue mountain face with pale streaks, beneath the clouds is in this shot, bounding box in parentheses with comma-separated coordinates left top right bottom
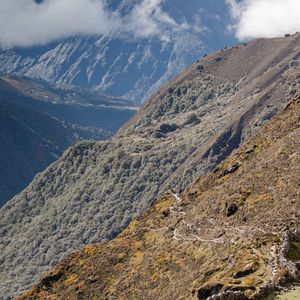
(0, 0, 237, 103)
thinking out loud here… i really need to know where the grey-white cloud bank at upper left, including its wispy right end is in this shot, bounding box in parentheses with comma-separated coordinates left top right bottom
(0, 0, 179, 49)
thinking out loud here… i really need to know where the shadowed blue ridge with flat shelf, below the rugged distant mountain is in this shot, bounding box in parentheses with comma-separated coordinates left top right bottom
(0, 75, 139, 133)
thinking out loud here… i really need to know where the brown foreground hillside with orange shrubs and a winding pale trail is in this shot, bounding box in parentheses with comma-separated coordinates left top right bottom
(18, 90, 300, 300)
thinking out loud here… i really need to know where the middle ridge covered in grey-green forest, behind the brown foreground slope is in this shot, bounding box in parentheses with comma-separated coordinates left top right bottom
(0, 34, 300, 299)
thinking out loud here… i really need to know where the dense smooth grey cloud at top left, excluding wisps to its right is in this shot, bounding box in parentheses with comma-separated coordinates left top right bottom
(0, 0, 118, 48)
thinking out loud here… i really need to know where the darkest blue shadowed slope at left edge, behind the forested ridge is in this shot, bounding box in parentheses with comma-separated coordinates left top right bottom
(0, 99, 111, 206)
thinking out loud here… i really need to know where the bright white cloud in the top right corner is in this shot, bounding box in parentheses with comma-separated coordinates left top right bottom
(226, 0, 300, 40)
